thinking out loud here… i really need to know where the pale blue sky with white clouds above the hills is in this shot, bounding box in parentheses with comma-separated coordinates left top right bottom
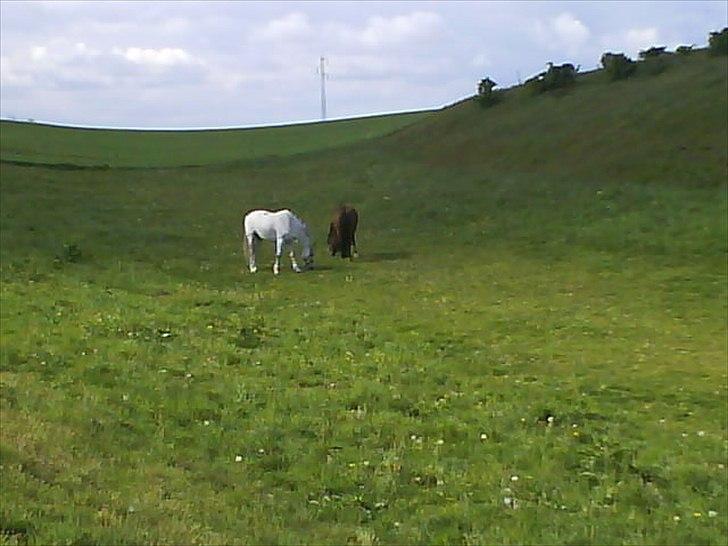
(0, 0, 728, 127)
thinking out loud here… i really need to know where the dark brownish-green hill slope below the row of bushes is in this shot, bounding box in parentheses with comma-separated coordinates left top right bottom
(388, 51, 728, 186)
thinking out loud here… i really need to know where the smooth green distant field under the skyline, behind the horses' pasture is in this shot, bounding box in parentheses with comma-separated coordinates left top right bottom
(0, 112, 430, 167)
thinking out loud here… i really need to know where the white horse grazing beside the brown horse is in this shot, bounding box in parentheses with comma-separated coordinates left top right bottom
(243, 209, 313, 275)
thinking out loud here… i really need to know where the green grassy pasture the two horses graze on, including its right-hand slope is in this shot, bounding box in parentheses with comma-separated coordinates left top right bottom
(0, 49, 728, 545)
